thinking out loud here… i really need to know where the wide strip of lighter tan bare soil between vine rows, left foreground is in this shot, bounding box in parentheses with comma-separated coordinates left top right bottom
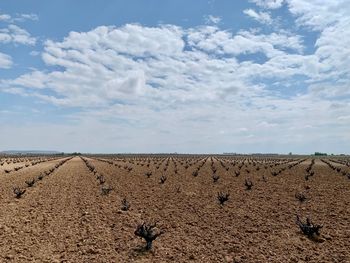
(0, 158, 117, 262)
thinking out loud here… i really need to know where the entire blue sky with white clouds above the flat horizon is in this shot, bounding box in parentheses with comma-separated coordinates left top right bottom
(0, 0, 350, 154)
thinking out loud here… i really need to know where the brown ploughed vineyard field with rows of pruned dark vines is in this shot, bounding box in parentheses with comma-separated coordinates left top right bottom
(0, 155, 350, 263)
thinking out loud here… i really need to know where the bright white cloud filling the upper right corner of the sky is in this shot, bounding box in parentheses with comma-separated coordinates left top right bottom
(288, 0, 350, 96)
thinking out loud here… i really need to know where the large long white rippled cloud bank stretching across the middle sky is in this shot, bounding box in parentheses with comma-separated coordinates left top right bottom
(1, 24, 303, 107)
